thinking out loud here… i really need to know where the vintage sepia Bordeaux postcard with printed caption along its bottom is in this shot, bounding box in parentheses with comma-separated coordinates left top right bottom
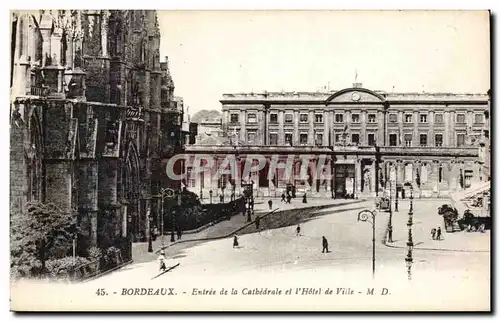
(9, 9, 491, 311)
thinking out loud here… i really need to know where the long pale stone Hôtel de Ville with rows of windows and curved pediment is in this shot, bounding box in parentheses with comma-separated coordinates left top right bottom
(186, 83, 490, 197)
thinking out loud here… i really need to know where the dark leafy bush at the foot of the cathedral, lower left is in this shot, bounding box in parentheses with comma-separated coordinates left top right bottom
(10, 202, 78, 276)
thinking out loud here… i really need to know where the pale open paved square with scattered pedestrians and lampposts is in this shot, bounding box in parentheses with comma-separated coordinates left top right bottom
(86, 199, 490, 306)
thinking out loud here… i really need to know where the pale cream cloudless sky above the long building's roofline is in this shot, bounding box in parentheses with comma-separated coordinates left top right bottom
(158, 10, 490, 115)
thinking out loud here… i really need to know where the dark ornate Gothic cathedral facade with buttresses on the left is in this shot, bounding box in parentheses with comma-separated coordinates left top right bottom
(10, 10, 189, 252)
